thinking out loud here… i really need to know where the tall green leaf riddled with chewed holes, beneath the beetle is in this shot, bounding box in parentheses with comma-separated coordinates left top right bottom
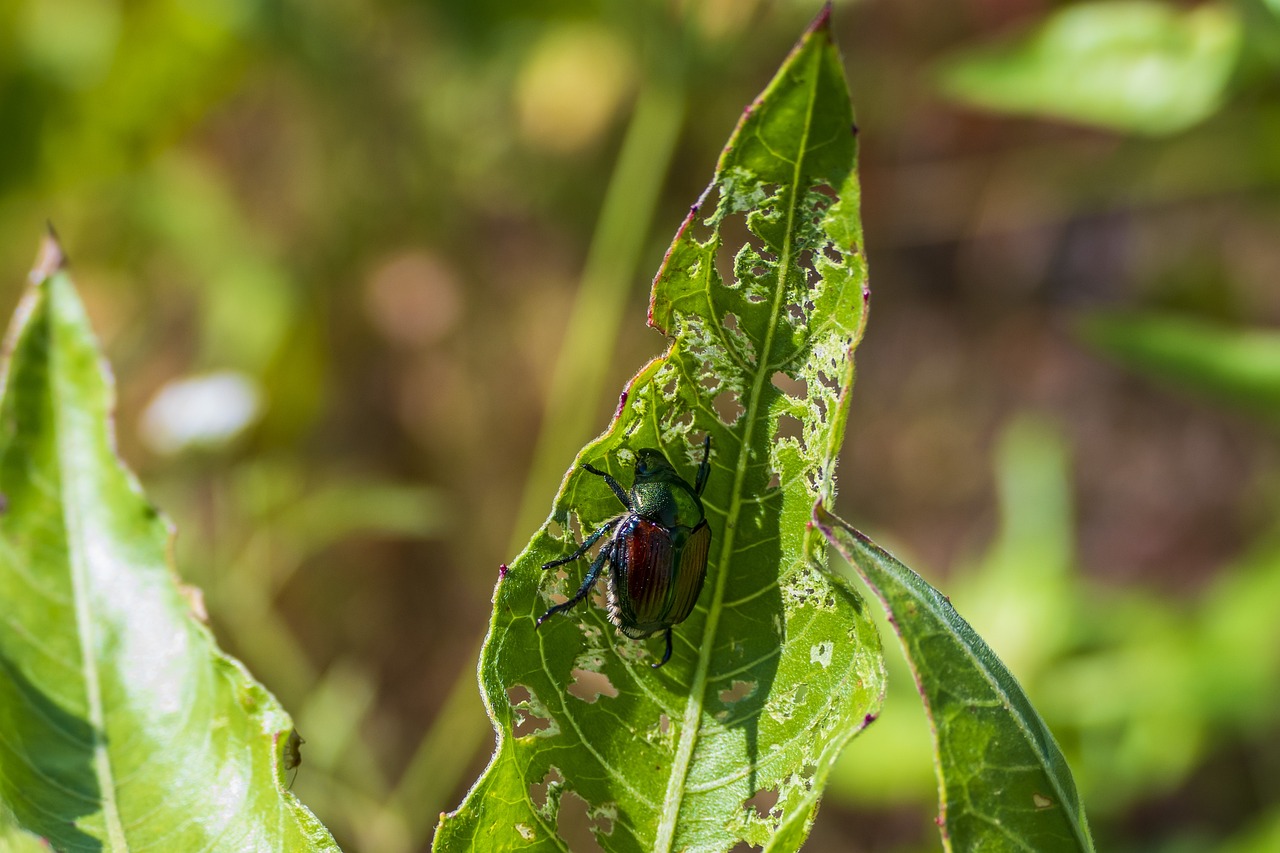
(435, 13, 883, 852)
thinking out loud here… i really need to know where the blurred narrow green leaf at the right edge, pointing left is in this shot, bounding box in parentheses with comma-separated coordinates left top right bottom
(1079, 313, 1280, 418)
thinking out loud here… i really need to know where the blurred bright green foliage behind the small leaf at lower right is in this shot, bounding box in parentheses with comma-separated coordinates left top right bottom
(832, 409, 1280, 853)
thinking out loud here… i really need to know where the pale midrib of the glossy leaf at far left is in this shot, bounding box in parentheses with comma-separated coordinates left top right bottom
(44, 278, 128, 850)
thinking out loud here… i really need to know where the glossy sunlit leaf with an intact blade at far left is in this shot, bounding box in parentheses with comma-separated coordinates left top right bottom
(0, 240, 337, 850)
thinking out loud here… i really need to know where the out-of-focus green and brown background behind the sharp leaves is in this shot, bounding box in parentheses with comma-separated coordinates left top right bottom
(0, 0, 1280, 853)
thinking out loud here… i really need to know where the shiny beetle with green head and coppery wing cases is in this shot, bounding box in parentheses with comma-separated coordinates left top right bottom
(538, 435, 712, 669)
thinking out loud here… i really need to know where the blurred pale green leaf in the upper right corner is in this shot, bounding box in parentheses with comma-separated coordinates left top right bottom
(938, 0, 1243, 136)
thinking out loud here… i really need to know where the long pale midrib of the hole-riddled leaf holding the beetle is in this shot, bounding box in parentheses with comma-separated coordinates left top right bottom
(654, 41, 820, 853)
